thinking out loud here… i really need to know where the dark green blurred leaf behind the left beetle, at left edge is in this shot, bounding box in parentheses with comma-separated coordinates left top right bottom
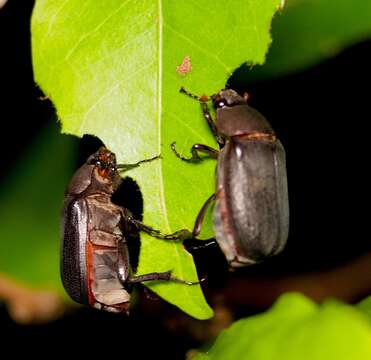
(0, 124, 76, 293)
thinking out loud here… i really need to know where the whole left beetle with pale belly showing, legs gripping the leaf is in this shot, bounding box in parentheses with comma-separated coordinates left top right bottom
(60, 147, 199, 313)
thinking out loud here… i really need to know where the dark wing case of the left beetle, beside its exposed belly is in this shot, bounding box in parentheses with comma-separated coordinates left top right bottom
(61, 197, 88, 304)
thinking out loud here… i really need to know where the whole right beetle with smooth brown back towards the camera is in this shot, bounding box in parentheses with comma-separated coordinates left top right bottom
(171, 88, 289, 268)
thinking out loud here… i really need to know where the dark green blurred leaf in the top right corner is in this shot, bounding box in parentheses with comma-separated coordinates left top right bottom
(248, 0, 371, 79)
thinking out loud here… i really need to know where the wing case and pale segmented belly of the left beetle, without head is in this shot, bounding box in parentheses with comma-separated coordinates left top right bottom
(61, 195, 130, 312)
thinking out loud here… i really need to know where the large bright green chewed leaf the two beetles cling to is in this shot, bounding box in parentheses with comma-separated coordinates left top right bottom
(32, 0, 280, 319)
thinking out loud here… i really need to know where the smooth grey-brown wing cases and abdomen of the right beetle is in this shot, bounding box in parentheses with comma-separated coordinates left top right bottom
(214, 137, 289, 266)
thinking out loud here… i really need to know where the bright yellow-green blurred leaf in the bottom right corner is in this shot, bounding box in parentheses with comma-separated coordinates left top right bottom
(193, 293, 371, 360)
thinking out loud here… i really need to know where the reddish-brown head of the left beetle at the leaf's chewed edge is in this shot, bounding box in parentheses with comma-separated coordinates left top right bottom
(86, 147, 121, 193)
